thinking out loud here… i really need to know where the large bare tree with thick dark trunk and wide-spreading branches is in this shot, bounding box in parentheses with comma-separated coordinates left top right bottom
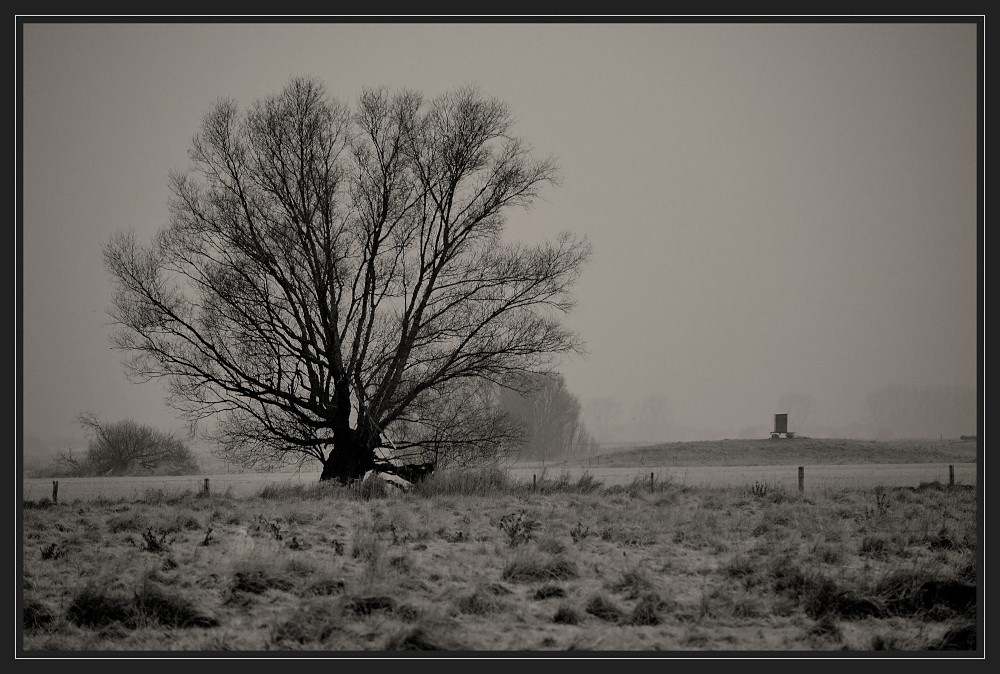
(105, 78, 590, 481)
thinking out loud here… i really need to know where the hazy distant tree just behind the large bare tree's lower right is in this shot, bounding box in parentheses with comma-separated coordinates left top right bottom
(497, 375, 598, 459)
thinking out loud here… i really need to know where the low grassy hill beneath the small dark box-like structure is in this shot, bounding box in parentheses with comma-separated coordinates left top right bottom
(594, 438, 977, 467)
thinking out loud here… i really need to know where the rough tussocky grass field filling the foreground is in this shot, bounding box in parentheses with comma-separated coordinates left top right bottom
(22, 464, 978, 655)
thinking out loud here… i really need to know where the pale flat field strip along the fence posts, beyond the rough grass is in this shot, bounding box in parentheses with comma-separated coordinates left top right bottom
(22, 463, 976, 502)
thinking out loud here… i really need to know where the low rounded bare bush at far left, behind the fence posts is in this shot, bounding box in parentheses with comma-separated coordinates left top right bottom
(68, 412, 198, 475)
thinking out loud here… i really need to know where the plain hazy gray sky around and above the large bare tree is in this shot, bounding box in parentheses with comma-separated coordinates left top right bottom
(21, 22, 979, 438)
